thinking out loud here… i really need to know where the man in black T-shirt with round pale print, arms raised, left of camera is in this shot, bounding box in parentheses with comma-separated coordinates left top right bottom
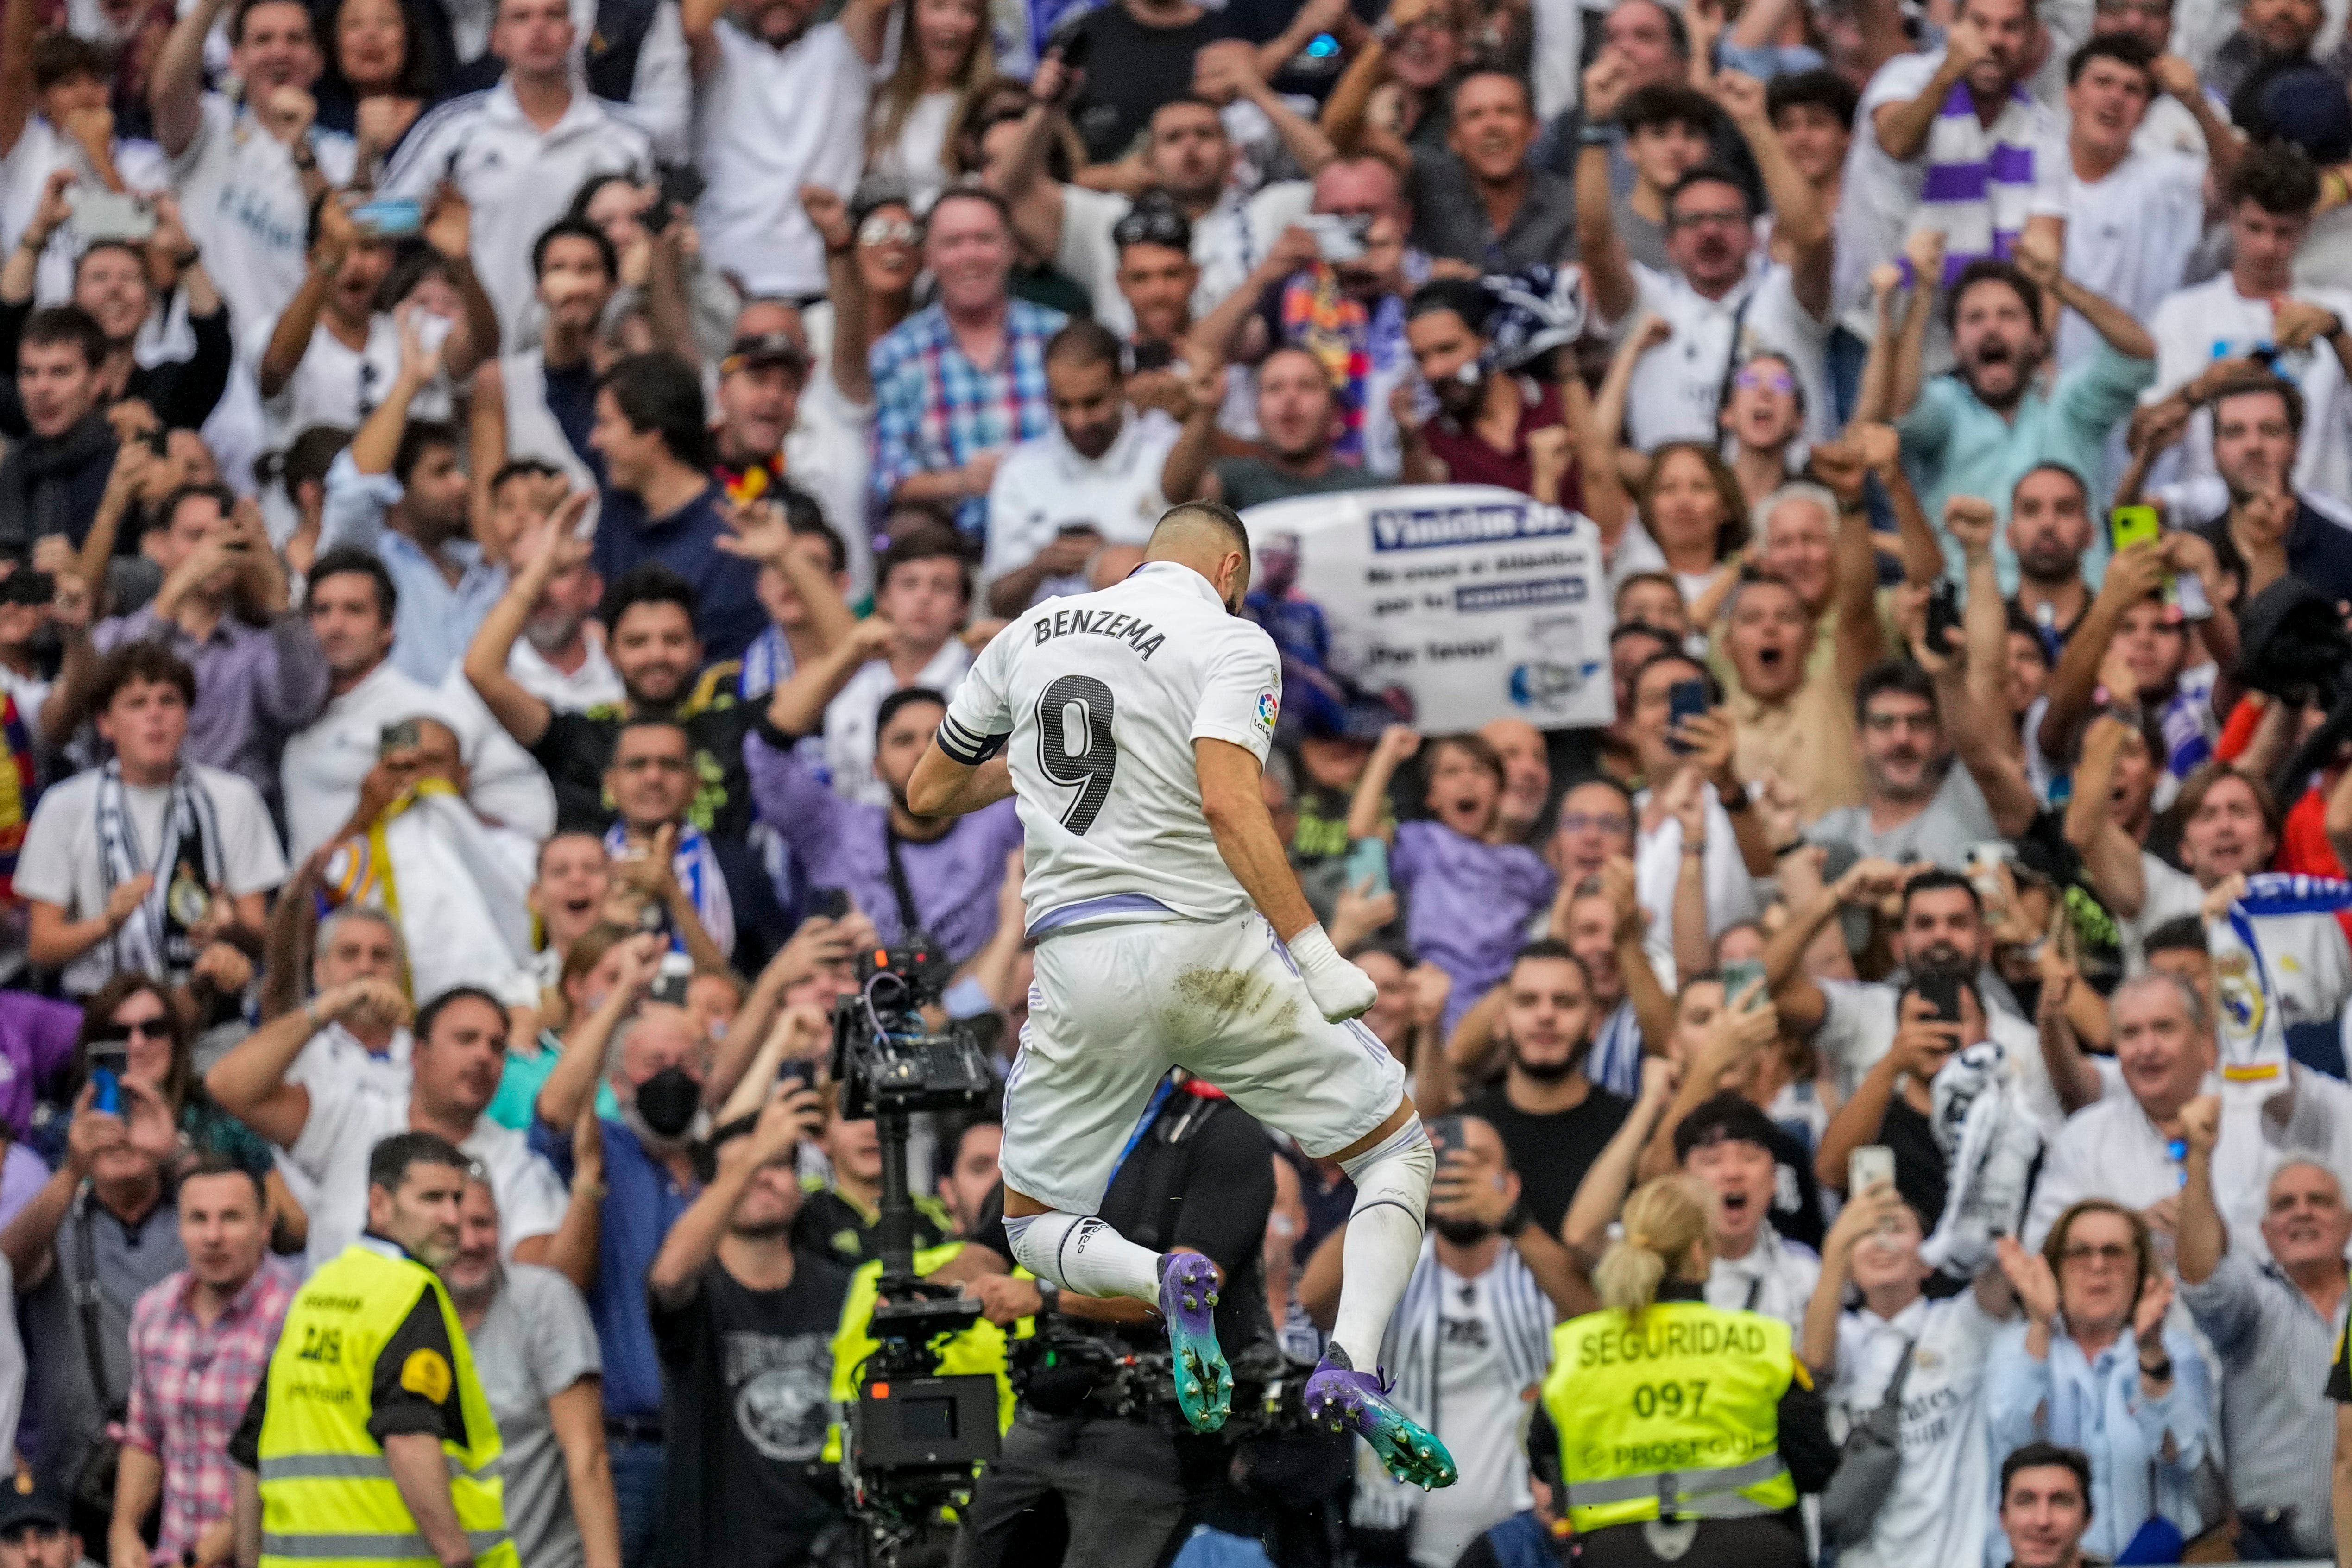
(644, 1086, 849, 1568)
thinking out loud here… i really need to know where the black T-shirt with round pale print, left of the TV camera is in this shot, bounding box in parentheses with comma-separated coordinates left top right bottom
(651, 1248, 849, 1568)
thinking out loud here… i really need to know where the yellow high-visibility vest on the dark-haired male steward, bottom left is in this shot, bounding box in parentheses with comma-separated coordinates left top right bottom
(261, 1239, 520, 1568)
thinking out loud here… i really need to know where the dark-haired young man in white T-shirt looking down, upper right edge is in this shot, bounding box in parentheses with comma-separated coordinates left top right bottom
(2143, 146, 2352, 503)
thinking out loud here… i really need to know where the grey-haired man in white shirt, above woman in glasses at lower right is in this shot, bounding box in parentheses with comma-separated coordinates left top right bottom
(2025, 971, 2352, 1251)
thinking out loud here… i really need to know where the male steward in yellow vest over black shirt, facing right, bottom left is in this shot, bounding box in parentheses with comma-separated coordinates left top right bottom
(247, 1133, 520, 1568)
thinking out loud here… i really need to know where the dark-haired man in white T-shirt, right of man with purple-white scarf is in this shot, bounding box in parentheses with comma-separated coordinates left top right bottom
(2056, 33, 2206, 385)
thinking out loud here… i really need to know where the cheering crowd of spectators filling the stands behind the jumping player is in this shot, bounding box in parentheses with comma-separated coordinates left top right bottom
(0, 0, 2352, 1568)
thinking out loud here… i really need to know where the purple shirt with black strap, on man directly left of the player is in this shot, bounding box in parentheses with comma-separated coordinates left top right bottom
(743, 724, 1021, 964)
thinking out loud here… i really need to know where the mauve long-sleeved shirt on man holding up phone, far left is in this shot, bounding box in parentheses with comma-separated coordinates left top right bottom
(89, 604, 327, 806)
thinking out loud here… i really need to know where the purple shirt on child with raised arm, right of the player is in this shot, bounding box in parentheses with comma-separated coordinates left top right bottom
(1387, 823, 1552, 1034)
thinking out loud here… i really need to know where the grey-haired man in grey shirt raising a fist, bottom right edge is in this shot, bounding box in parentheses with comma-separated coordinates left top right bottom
(2175, 1096, 2352, 1559)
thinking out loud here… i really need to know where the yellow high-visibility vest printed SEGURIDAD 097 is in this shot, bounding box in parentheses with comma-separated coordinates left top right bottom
(1543, 1303, 1804, 1530)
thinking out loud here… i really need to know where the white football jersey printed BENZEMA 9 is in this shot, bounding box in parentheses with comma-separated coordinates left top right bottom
(939, 562, 1282, 936)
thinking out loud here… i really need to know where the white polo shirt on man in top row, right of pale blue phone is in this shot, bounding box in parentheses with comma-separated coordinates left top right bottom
(384, 77, 654, 343)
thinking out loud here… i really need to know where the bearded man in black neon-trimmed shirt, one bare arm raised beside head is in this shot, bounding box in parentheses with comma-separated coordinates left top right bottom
(466, 517, 757, 839)
